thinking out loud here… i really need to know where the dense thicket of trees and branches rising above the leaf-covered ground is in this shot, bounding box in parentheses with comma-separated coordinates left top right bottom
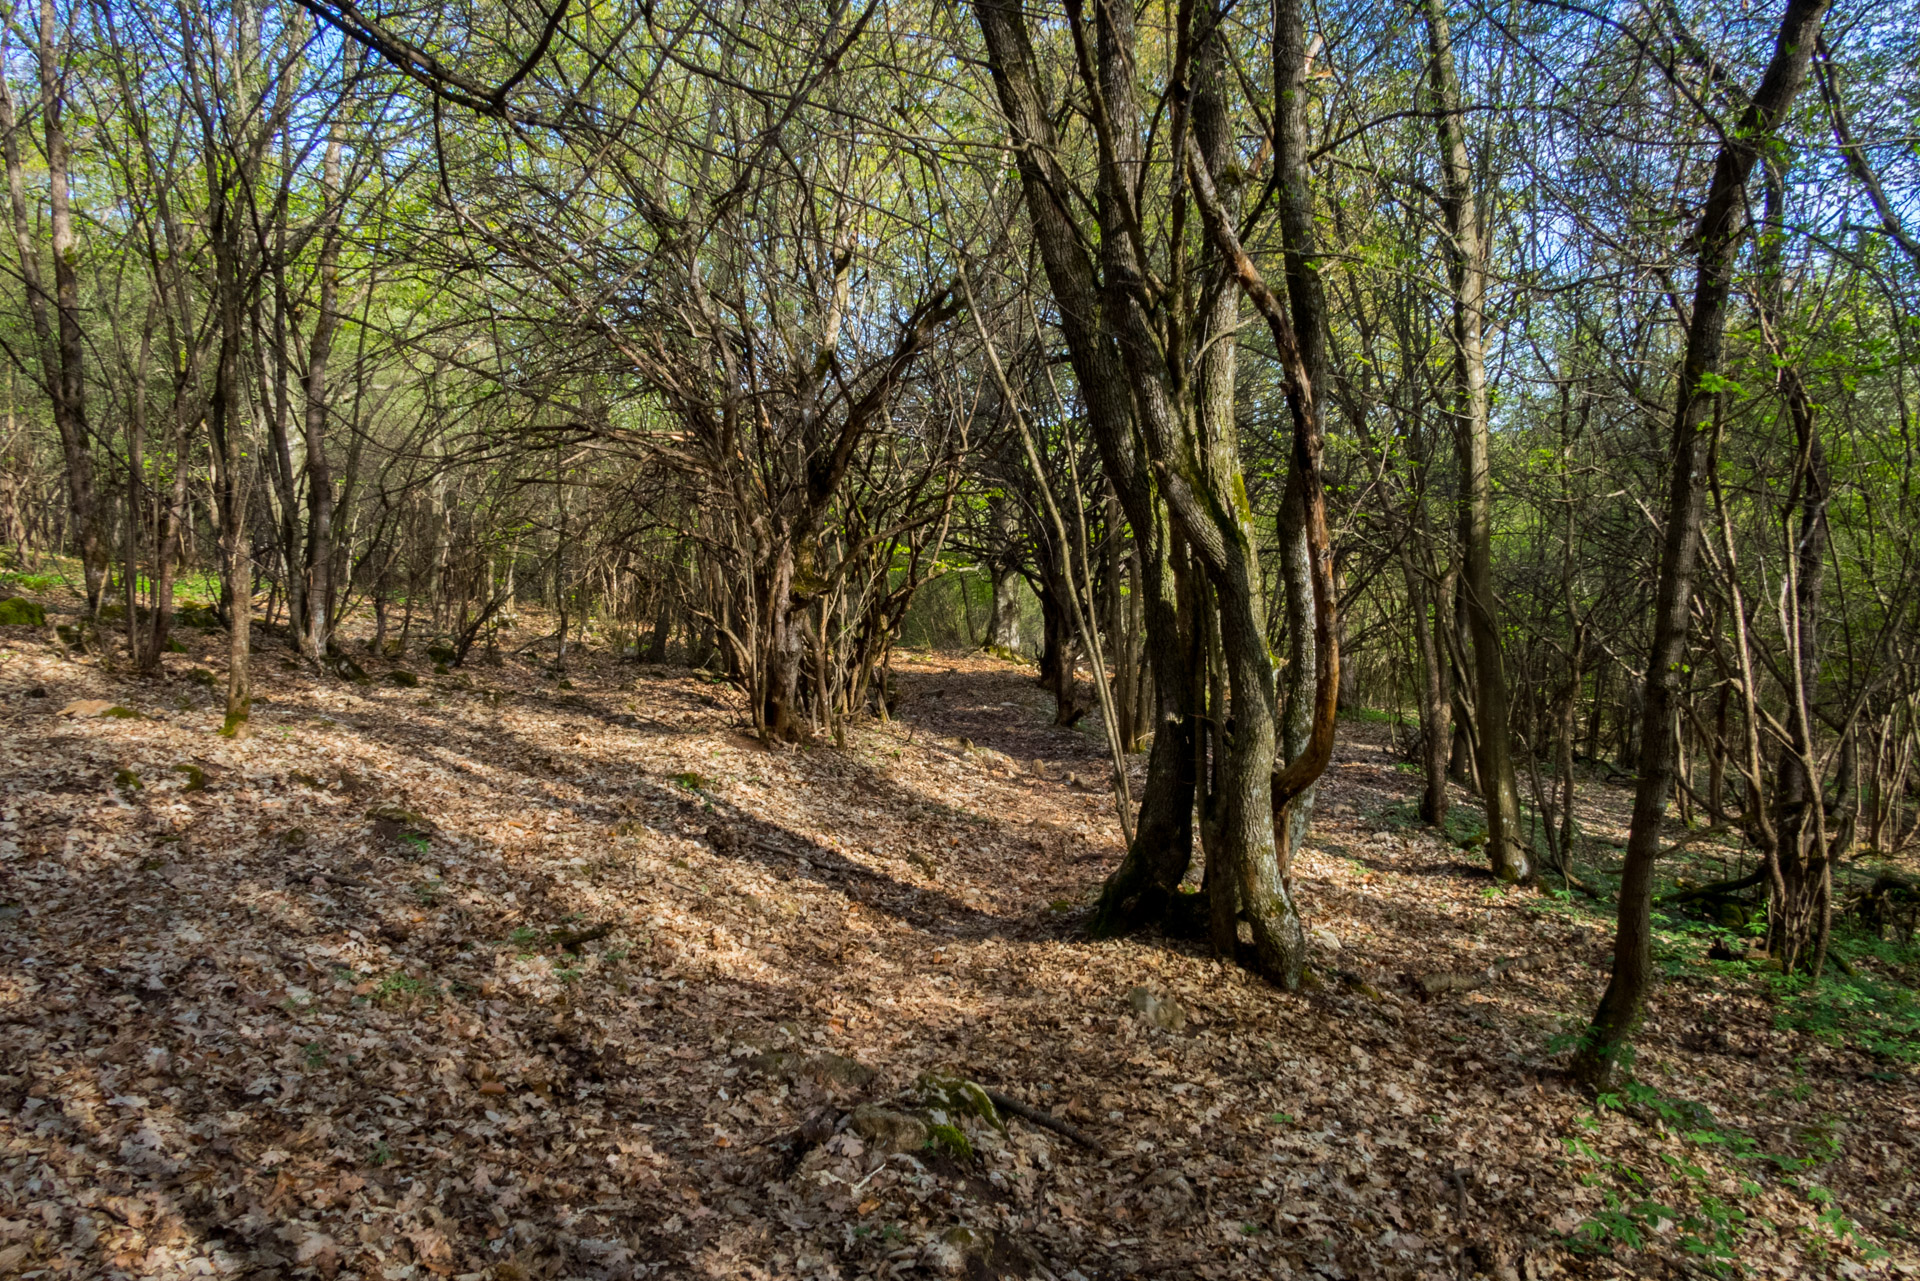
(0, 0, 1920, 1081)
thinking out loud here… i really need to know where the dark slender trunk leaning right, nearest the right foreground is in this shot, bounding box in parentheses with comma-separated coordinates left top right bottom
(1572, 0, 1826, 1089)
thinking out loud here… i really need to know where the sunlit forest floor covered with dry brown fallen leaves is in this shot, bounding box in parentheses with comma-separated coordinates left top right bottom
(0, 595, 1920, 1281)
